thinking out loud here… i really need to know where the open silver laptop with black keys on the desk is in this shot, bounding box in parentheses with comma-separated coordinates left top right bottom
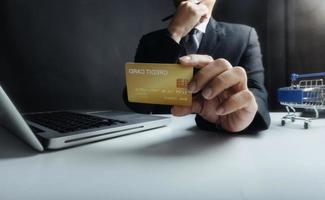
(0, 86, 171, 151)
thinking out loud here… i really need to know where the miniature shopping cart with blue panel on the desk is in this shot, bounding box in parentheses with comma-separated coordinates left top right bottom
(278, 72, 325, 129)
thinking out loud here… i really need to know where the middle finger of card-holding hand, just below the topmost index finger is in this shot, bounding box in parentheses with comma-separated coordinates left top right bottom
(188, 59, 232, 93)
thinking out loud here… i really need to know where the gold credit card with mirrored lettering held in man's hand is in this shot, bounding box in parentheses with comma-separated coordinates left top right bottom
(125, 63, 193, 106)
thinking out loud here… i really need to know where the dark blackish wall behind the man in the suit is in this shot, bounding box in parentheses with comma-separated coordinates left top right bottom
(0, 0, 325, 112)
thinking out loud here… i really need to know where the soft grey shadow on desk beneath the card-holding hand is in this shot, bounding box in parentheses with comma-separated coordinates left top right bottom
(133, 126, 259, 156)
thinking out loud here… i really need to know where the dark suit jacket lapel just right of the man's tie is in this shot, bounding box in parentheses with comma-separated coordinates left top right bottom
(198, 18, 224, 59)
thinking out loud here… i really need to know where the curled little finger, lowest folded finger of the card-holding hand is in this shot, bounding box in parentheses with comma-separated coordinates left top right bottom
(216, 90, 257, 115)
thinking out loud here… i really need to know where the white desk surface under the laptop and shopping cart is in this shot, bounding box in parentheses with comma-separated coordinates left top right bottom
(0, 113, 325, 200)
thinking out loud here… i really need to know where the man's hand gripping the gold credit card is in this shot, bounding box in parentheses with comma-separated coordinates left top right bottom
(172, 55, 253, 121)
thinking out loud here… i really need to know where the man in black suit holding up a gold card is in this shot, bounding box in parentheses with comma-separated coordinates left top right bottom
(124, 0, 270, 132)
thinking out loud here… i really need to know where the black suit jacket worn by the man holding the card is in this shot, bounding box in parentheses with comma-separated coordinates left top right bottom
(124, 18, 270, 131)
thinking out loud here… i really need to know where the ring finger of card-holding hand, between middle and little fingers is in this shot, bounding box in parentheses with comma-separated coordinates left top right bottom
(198, 67, 247, 100)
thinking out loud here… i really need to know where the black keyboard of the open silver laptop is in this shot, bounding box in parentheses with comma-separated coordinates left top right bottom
(24, 111, 126, 133)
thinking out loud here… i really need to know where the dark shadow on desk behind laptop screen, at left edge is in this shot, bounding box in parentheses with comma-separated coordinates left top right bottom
(0, 127, 38, 160)
